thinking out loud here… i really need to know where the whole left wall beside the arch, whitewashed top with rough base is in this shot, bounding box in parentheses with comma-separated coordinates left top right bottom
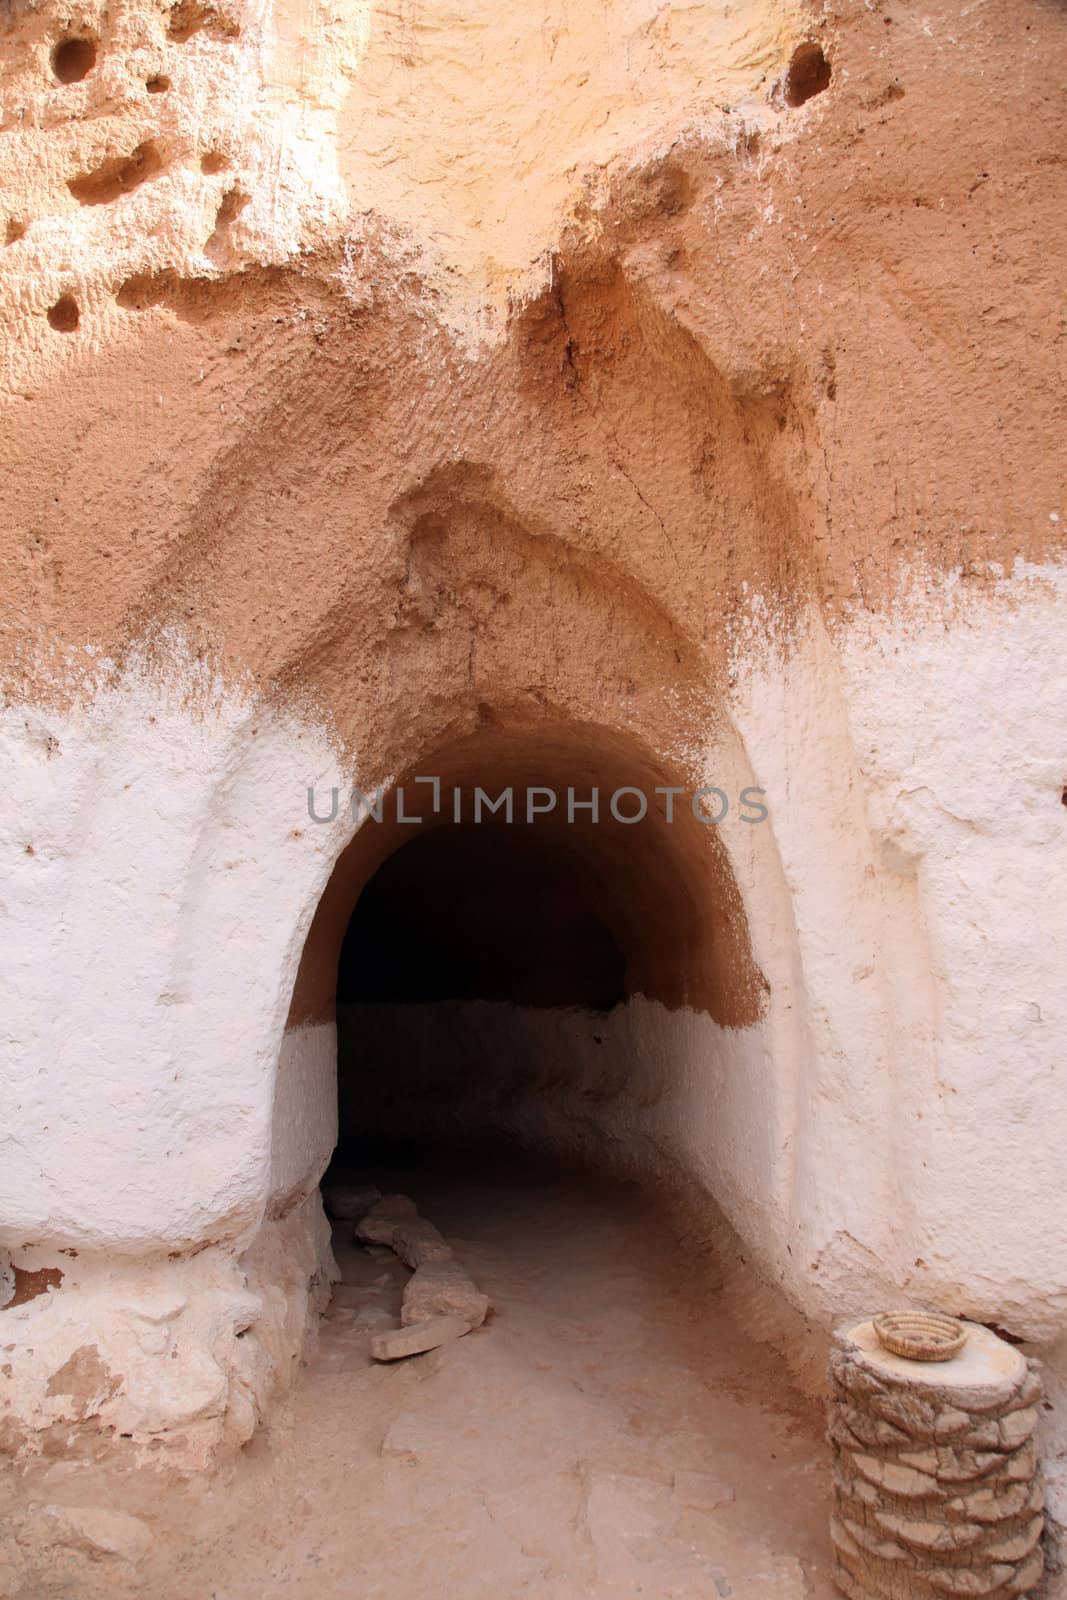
(0, 653, 352, 1462)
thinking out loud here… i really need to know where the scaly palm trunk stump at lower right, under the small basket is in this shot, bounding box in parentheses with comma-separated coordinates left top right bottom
(830, 1322, 1045, 1600)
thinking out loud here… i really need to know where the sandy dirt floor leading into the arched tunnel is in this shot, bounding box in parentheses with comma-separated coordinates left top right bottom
(0, 1163, 833, 1600)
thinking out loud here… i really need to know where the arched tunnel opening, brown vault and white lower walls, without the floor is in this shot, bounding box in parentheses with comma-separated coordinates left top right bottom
(275, 720, 765, 1376)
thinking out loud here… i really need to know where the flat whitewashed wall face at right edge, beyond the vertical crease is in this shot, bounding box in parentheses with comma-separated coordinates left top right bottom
(841, 568, 1067, 1339)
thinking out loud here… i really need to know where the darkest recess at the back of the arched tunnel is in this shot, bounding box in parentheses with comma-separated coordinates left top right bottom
(336, 819, 633, 1170)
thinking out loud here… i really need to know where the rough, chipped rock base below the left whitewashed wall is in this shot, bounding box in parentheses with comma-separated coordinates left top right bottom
(0, 1195, 338, 1470)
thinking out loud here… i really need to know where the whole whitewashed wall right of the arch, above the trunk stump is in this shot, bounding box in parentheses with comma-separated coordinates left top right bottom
(725, 566, 1067, 1341)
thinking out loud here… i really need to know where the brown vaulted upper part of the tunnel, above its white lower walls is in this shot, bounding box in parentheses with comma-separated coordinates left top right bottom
(290, 726, 766, 1027)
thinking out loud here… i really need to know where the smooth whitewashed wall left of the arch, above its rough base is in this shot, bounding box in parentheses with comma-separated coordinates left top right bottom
(0, 643, 356, 1254)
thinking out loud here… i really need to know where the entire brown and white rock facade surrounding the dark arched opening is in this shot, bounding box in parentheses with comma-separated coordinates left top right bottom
(0, 0, 1067, 1478)
